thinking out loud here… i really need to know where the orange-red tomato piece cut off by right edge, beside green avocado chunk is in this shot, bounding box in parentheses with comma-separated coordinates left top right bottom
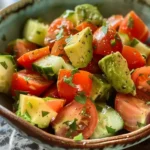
(131, 66, 150, 95)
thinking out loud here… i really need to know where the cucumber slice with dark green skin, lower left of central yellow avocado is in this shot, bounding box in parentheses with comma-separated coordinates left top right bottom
(32, 55, 73, 79)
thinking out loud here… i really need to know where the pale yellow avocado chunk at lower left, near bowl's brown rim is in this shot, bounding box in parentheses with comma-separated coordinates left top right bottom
(17, 94, 57, 128)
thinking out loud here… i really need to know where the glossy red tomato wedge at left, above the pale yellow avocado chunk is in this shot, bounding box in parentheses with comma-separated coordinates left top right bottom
(11, 70, 53, 96)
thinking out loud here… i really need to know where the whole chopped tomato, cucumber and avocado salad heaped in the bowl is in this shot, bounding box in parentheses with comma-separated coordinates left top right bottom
(0, 4, 150, 141)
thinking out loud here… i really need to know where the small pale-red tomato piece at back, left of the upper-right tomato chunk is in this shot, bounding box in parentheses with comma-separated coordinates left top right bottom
(107, 15, 123, 30)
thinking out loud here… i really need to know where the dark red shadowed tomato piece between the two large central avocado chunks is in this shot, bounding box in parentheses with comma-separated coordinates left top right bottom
(82, 54, 103, 74)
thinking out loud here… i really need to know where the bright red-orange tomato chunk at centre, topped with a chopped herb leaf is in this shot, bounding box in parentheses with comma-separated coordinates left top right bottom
(57, 69, 92, 103)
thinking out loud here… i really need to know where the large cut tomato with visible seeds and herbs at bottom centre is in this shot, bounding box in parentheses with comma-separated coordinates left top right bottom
(52, 100, 98, 139)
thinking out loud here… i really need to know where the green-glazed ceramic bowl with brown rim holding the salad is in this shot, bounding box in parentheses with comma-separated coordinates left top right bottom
(0, 0, 150, 150)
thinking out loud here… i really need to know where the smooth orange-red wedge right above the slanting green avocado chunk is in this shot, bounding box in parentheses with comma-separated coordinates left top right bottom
(122, 45, 146, 70)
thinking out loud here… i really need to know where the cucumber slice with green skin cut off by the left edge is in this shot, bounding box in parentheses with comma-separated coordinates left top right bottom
(0, 55, 16, 93)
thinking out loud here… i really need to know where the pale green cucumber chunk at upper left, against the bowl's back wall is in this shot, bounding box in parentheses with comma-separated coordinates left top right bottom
(23, 19, 48, 46)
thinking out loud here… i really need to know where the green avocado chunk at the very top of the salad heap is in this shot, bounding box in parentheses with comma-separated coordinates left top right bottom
(75, 4, 102, 26)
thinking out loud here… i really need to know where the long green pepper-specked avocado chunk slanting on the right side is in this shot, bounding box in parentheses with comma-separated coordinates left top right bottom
(98, 52, 136, 95)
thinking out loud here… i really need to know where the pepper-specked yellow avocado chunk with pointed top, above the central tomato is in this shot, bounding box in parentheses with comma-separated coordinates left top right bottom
(64, 27, 93, 68)
